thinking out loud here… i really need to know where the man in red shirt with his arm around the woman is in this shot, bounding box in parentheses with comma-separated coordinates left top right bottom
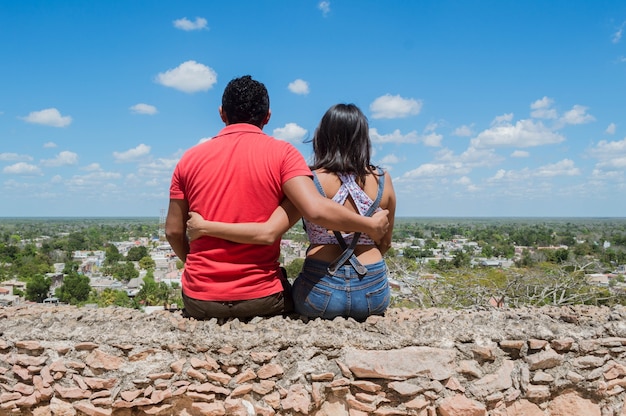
(165, 75, 389, 319)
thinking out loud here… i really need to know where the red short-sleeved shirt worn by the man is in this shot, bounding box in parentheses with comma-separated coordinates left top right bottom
(170, 123, 311, 301)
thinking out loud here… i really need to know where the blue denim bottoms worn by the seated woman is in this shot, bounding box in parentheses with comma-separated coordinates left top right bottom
(292, 258, 391, 321)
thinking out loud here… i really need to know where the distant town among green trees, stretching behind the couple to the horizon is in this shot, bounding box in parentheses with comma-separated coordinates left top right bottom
(0, 219, 626, 310)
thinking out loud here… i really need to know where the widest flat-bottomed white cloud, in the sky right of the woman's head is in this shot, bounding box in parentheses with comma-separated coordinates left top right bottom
(471, 120, 565, 147)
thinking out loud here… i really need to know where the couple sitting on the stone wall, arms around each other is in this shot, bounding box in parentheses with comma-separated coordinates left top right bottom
(166, 76, 395, 320)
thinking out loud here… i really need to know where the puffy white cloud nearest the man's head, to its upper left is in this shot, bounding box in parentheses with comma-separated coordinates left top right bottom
(156, 61, 217, 93)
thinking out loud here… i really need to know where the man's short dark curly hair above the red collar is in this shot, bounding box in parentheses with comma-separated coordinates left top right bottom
(222, 75, 270, 128)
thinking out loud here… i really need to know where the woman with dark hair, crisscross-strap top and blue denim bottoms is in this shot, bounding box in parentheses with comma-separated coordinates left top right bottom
(187, 104, 396, 320)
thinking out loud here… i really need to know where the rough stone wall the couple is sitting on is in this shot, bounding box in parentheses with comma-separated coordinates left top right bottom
(0, 305, 626, 416)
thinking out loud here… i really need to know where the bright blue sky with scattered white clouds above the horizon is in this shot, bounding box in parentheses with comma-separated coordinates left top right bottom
(0, 0, 626, 217)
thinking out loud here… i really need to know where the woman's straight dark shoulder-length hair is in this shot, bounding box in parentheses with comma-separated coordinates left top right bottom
(311, 104, 376, 185)
